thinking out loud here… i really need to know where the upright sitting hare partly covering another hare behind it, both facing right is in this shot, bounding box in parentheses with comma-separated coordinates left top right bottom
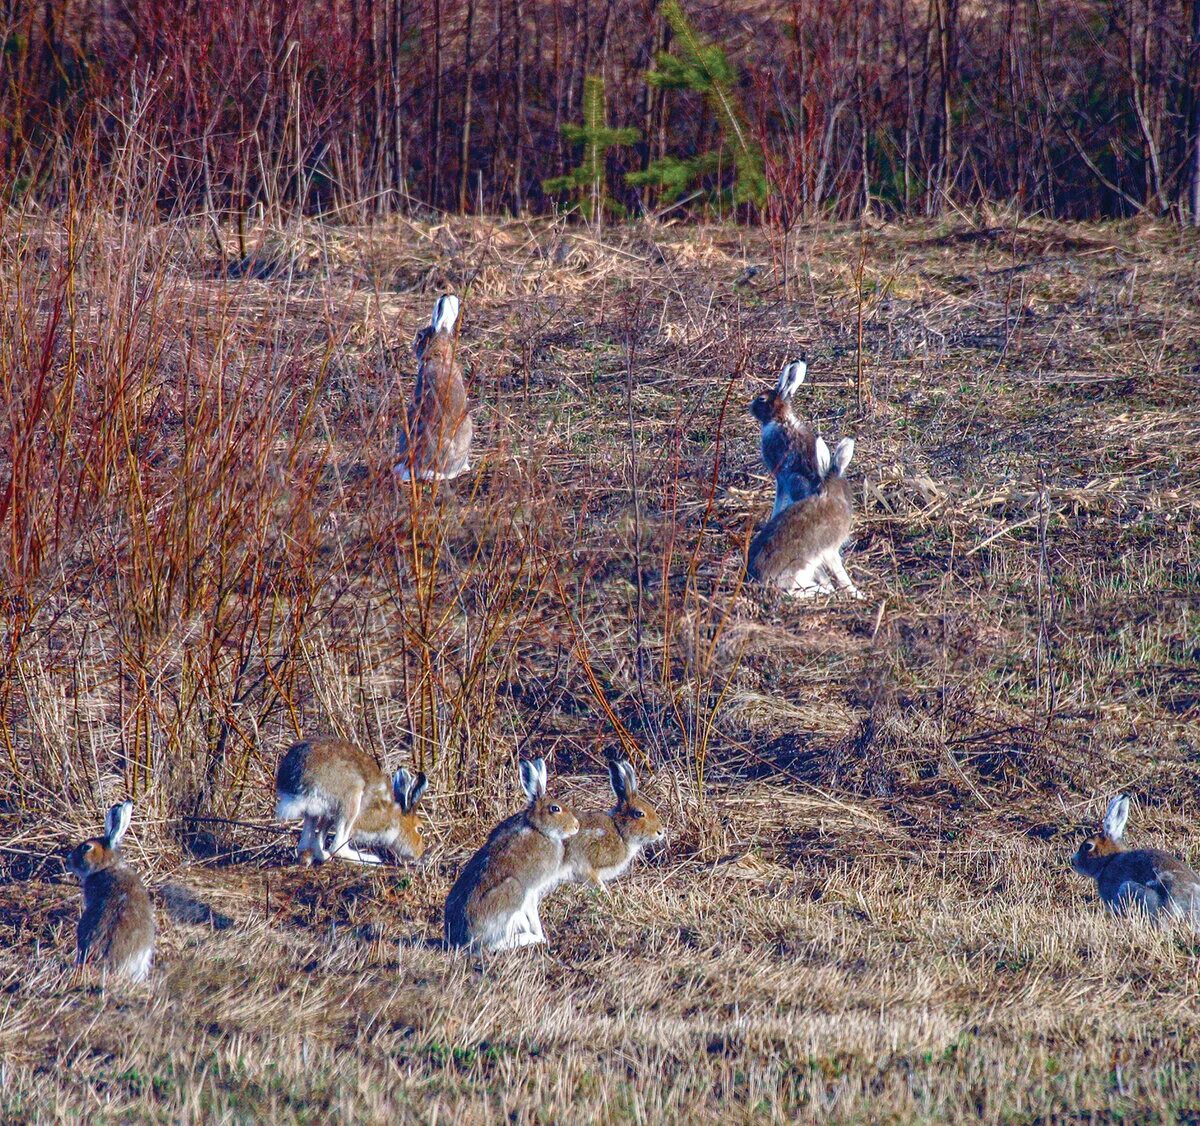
(445, 759, 580, 951)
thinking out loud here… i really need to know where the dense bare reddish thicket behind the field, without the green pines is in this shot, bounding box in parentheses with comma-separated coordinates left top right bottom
(7, 0, 1200, 222)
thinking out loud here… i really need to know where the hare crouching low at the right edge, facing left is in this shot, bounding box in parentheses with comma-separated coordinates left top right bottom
(1070, 795, 1200, 924)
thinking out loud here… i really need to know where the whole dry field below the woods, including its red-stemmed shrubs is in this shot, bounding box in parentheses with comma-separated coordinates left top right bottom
(0, 204, 1200, 1124)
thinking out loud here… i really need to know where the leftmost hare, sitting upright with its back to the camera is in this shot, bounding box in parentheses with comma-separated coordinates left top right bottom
(67, 802, 155, 981)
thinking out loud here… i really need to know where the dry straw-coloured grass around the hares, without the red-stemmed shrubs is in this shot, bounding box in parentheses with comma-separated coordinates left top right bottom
(0, 208, 1200, 1121)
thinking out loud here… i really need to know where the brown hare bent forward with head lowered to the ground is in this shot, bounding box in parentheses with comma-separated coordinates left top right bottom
(275, 738, 427, 864)
